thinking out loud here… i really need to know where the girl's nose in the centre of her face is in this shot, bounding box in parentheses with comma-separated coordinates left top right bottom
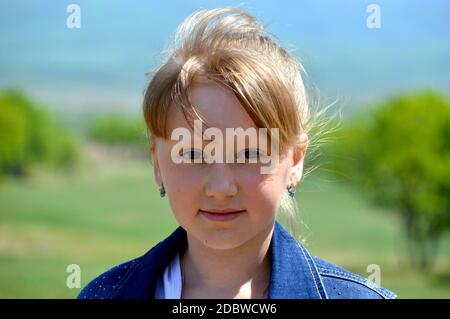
(206, 163, 237, 200)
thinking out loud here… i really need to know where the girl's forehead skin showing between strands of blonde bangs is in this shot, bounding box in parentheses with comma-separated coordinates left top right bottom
(167, 82, 257, 135)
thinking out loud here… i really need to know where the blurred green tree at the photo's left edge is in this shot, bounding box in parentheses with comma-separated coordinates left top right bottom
(0, 91, 79, 176)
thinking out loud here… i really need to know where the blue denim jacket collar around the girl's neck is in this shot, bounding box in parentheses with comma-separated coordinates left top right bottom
(113, 221, 327, 299)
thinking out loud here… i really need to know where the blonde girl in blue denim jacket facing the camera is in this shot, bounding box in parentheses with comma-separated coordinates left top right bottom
(79, 8, 395, 299)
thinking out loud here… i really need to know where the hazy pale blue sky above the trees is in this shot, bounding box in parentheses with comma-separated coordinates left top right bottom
(0, 0, 450, 114)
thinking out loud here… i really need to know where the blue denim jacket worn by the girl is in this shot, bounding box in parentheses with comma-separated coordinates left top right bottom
(78, 221, 397, 299)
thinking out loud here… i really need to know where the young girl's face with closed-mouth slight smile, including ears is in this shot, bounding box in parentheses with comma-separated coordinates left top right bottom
(152, 83, 304, 249)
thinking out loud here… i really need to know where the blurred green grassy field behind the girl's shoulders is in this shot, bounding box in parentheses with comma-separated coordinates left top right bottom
(0, 151, 450, 298)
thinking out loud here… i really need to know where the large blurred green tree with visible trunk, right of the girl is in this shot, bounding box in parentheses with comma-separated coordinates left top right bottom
(328, 92, 450, 270)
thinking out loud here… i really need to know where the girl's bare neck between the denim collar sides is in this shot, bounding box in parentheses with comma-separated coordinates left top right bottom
(181, 224, 273, 298)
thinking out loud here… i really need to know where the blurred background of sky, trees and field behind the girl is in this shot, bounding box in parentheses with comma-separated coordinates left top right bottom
(0, 0, 450, 298)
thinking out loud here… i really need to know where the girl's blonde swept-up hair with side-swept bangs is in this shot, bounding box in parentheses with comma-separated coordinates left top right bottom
(143, 8, 336, 242)
